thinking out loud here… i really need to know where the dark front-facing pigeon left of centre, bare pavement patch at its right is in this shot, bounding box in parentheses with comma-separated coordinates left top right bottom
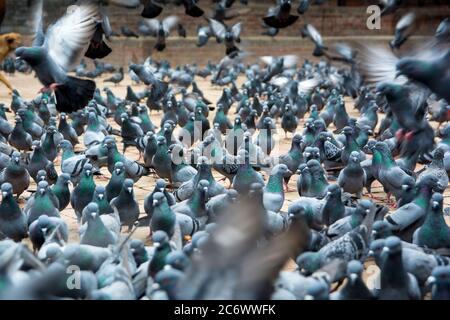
(111, 179, 140, 232)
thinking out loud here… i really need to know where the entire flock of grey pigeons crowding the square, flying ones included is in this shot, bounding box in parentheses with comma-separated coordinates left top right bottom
(0, 0, 450, 300)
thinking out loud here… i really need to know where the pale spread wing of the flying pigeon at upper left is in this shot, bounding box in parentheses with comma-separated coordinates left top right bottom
(44, 1, 101, 70)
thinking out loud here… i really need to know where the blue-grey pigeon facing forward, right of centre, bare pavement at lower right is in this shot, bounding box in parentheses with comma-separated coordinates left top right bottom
(338, 151, 367, 198)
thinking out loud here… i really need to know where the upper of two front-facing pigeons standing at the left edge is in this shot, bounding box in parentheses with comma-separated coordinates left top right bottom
(0, 151, 30, 198)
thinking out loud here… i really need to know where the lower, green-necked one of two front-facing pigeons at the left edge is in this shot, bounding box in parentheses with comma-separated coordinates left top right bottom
(0, 182, 28, 242)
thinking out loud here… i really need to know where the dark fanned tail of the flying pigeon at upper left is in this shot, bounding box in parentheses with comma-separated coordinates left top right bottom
(55, 76, 96, 113)
